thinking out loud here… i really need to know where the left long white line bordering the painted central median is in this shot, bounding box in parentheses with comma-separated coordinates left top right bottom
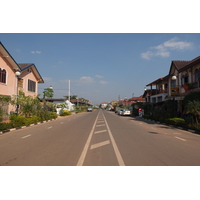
(77, 113, 99, 166)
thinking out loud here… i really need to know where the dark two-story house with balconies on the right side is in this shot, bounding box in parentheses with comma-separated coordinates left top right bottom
(143, 56, 200, 103)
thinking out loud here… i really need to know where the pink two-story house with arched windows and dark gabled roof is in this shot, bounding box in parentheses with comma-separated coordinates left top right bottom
(0, 42, 44, 117)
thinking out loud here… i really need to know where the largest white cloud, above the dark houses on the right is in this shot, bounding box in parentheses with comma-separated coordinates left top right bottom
(141, 37, 193, 60)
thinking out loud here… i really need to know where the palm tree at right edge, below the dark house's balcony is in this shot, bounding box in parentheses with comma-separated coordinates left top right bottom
(186, 100, 200, 124)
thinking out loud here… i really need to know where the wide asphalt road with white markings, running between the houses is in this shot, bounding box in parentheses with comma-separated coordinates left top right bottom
(0, 110, 200, 166)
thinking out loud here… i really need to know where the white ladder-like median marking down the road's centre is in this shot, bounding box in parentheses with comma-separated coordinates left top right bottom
(77, 110, 125, 166)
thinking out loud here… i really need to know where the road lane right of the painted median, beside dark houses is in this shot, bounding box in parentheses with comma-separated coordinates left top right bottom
(105, 112, 200, 166)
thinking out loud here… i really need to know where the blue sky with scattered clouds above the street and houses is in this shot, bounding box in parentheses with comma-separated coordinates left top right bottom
(0, 33, 200, 104)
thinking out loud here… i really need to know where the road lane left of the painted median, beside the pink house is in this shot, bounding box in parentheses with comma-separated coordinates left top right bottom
(0, 113, 96, 166)
